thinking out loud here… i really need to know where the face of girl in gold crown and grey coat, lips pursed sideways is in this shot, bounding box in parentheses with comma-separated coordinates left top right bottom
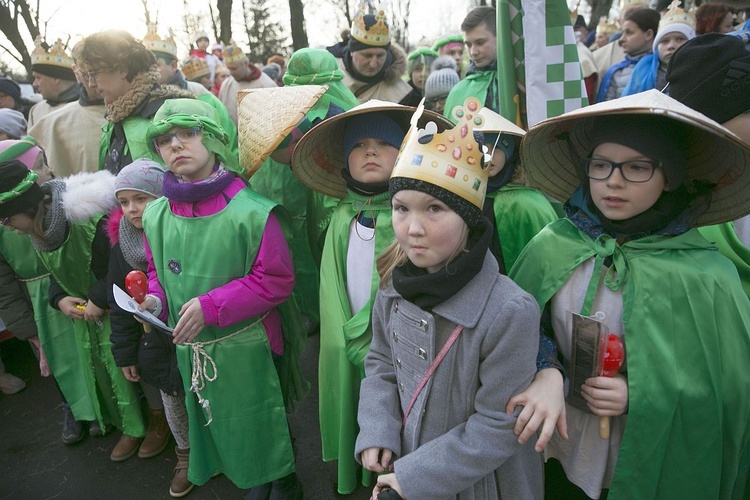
(392, 190, 469, 273)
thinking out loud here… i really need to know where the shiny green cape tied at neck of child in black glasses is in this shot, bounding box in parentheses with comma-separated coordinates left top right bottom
(510, 219, 750, 499)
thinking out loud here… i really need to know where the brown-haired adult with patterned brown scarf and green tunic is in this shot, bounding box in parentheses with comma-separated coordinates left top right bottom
(74, 30, 195, 174)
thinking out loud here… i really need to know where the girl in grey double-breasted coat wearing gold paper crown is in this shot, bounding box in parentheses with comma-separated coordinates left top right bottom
(356, 98, 543, 500)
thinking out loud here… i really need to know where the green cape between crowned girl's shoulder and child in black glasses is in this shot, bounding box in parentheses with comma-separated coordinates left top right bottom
(487, 184, 559, 269)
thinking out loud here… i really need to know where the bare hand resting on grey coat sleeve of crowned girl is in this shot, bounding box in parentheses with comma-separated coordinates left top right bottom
(505, 368, 568, 453)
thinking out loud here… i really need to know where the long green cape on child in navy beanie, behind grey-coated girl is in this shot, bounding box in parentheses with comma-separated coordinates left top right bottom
(318, 191, 394, 494)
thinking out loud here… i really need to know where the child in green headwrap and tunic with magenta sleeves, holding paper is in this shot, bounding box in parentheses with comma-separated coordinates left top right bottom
(139, 99, 307, 498)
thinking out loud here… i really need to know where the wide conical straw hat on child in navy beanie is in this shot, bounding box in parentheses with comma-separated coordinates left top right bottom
(292, 99, 454, 198)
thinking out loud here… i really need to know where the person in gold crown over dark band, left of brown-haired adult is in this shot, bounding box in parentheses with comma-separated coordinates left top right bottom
(28, 38, 78, 128)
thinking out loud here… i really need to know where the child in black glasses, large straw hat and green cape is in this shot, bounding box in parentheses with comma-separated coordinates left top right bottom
(510, 90, 750, 498)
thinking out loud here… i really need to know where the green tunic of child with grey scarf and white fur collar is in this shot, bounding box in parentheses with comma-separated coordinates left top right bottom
(37, 219, 146, 437)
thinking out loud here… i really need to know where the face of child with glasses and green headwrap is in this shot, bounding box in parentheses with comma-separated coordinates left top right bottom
(154, 128, 216, 182)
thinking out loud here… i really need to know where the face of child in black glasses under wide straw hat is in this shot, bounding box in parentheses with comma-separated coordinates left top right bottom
(589, 142, 668, 220)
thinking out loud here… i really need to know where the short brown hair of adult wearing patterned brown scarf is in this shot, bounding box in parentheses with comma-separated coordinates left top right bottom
(73, 30, 156, 82)
